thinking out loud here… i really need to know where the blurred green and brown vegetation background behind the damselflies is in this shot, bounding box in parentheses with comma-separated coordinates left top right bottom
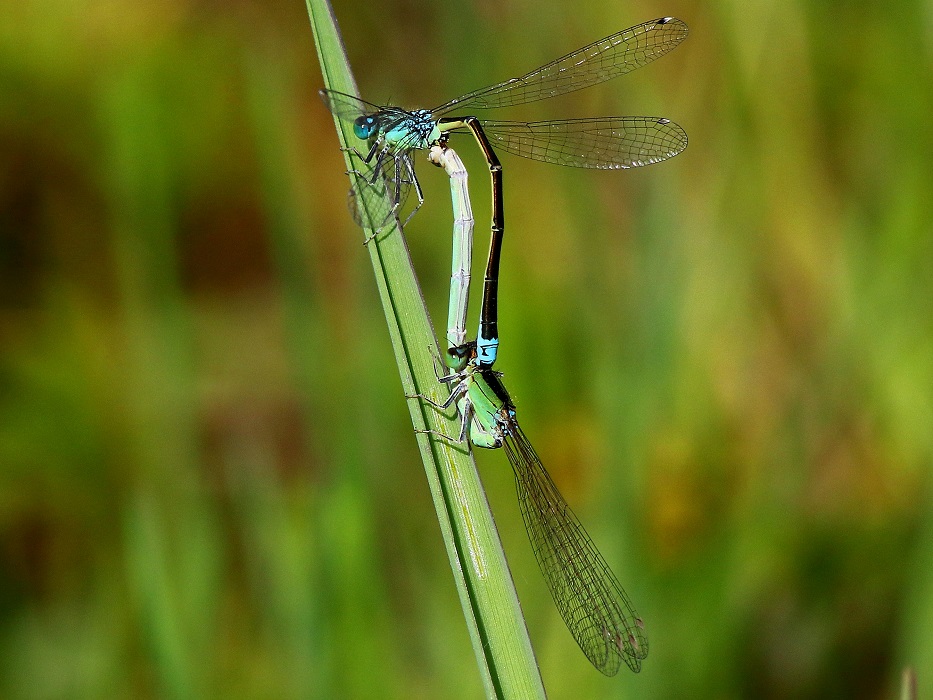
(0, 0, 933, 699)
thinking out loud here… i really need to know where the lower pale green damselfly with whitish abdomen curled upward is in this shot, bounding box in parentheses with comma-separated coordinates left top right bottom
(418, 146, 648, 675)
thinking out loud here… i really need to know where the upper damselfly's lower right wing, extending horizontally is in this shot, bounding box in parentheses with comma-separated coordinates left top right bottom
(474, 117, 687, 170)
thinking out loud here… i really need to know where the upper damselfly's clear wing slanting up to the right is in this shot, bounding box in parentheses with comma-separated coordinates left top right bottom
(432, 17, 687, 117)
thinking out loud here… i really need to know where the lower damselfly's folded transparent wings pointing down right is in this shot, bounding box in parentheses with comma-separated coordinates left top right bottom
(505, 425, 648, 676)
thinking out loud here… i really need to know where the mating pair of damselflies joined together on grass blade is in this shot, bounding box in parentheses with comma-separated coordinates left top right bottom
(322, 17, 687, 675)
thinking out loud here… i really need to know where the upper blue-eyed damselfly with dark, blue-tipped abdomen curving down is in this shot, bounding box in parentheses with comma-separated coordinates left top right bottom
(321, 17, 687, 367)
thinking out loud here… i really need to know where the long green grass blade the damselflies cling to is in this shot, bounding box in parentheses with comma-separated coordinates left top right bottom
(306, 0, 545, 698)
